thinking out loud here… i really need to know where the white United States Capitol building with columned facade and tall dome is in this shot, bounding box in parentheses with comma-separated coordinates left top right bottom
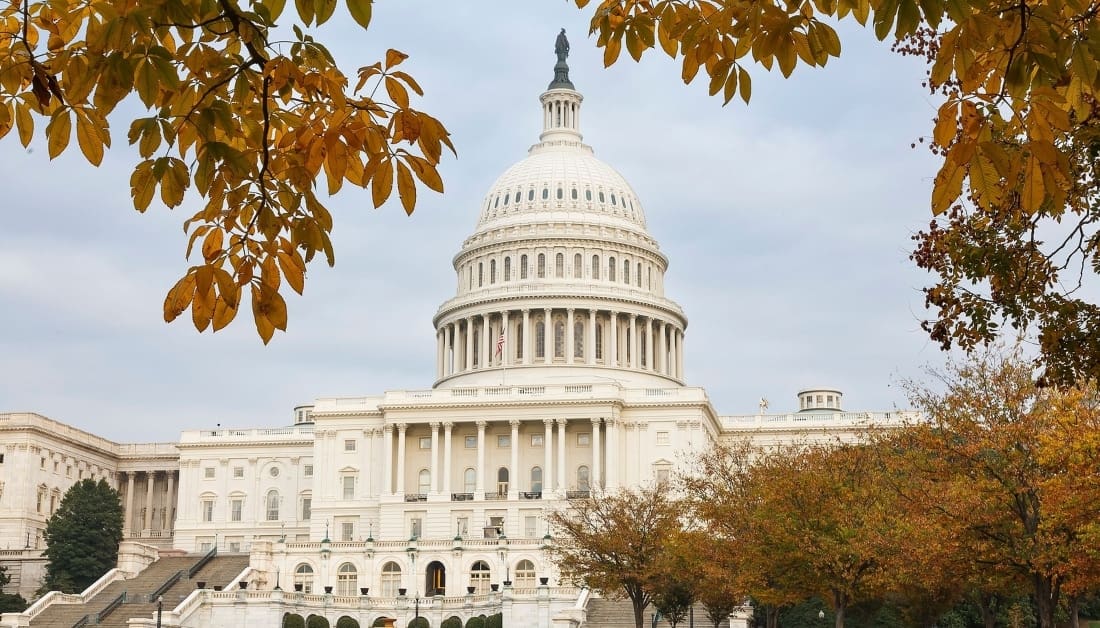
(0, 36, 906, 628)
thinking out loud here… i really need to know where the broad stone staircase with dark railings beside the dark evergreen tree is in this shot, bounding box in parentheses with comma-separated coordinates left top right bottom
(31, 554, 249, 628)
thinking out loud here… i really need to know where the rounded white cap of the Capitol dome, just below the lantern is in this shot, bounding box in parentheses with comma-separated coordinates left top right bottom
(477, 141, 646, 232)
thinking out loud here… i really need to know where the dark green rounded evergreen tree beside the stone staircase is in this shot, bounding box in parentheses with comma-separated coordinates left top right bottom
(42, 480, 122, 593)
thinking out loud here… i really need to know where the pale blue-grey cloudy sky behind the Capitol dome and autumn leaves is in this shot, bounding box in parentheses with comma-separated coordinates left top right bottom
(0, 0, 943, 442)
